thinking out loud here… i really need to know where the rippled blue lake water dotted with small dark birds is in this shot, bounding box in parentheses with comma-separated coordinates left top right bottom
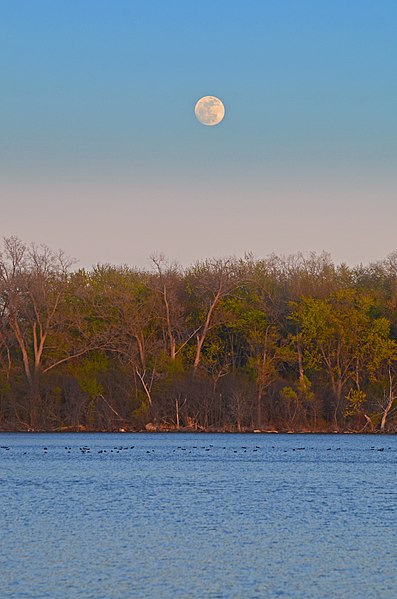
(0, 433, 397, 599)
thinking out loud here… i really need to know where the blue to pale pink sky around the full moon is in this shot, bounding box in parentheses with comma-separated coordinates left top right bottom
(0, 0, 397, 266)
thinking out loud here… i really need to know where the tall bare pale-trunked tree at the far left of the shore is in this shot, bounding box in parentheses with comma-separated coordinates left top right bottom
(0, 237, 71, 428)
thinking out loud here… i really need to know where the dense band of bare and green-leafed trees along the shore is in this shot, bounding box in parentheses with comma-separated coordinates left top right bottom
(0, 237, 397, 432)
